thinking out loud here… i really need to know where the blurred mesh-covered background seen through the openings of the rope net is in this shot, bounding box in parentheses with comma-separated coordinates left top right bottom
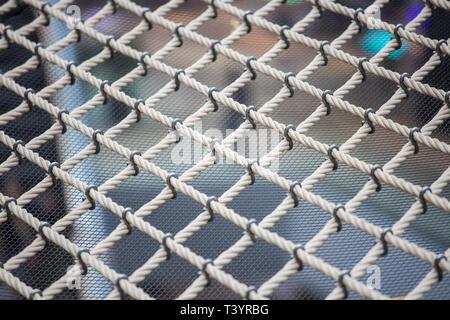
(0, 0, 450, 299)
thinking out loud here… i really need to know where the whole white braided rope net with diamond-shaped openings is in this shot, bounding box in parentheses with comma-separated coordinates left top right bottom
(0, 0, 450, 299)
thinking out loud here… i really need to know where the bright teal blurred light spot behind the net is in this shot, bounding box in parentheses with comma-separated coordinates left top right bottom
(359, 29, 409, 60)
